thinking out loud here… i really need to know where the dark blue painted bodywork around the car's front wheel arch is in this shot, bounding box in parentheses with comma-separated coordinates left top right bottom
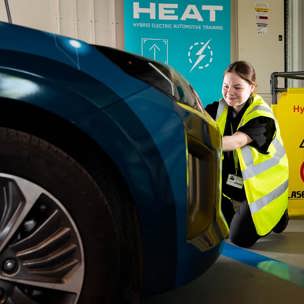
(0, 22, 221, 293)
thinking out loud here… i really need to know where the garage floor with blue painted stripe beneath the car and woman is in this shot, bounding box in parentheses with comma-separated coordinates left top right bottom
(144, 219, 304, 304)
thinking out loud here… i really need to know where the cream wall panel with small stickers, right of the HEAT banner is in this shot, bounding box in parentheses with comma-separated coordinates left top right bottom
(234, 0, 284, 102)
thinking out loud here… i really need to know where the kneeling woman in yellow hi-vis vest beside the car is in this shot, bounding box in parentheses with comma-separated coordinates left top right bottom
(206, 61, 288, 247)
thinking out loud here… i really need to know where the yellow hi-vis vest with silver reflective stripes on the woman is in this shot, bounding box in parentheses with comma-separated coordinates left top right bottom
(216, 95, 289, 236)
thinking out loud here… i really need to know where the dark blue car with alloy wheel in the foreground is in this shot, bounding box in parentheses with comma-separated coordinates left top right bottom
(0, 22, 228, 304)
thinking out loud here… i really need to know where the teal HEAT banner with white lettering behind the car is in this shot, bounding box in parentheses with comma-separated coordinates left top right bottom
(124, 0, 230, 105)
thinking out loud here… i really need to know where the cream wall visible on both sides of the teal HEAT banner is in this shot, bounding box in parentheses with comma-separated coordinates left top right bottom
(0, 0, 304, 96)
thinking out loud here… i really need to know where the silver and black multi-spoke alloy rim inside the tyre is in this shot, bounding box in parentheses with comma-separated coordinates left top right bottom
(0, 173, 85, 304)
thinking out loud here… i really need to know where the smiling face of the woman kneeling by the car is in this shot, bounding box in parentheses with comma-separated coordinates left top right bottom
(222, 72, 254, 112)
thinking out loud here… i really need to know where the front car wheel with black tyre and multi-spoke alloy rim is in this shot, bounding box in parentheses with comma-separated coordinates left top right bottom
(0, 128, 120, 304)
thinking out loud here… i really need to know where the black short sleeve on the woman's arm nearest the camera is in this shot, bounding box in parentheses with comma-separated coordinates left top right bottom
(239, 116, 276, 154)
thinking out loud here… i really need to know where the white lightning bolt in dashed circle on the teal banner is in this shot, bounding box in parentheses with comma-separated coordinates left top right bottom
(188, 40, 213, 72)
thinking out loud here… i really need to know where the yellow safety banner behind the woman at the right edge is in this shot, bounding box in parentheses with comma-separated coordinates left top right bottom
(273, 89, 304, 216)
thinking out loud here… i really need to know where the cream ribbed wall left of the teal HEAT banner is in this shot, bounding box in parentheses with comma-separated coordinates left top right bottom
(0, 0, 123, 48)
